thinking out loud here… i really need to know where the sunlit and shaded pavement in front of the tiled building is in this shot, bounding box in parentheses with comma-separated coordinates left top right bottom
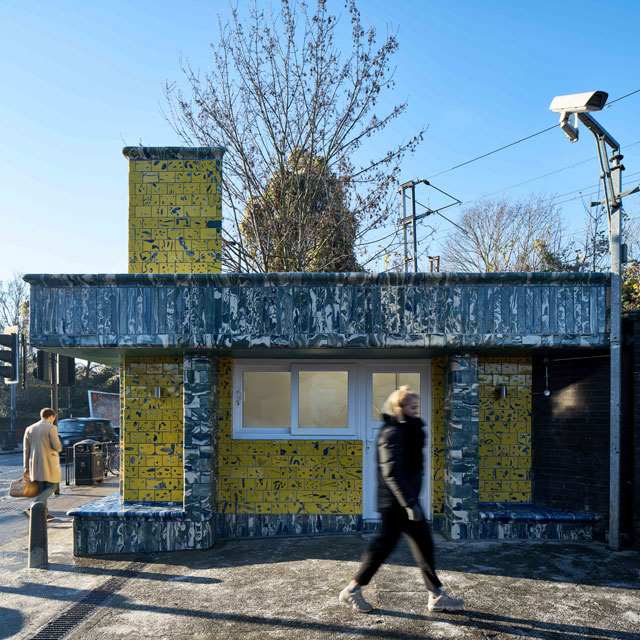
(0, 450, 640, 640)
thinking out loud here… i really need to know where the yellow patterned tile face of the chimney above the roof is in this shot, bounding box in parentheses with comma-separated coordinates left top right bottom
(129, 159, 222, 273)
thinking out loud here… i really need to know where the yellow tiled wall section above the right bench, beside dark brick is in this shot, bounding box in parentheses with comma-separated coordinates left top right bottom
(478, 357, 532, 502)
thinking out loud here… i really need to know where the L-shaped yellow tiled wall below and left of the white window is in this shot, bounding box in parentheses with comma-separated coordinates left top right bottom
(218, 358, 362, 514)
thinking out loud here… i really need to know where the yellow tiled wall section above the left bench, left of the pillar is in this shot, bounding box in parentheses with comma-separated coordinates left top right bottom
(121, 357, 184, 502)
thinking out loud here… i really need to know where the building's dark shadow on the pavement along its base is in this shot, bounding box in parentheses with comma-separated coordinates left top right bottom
(96, 535, 640, 590)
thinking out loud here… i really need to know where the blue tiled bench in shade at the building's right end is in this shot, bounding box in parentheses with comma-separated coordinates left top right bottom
(478, 503, 602, 540)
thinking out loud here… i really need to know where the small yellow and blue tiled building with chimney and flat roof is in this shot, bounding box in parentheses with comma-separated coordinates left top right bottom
(25, 148, 636, 555)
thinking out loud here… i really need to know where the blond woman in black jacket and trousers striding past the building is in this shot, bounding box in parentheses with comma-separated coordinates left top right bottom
(339, 387, 464, 613)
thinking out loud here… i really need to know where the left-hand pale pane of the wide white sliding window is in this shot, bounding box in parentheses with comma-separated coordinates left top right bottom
(242, 371, 291, 428)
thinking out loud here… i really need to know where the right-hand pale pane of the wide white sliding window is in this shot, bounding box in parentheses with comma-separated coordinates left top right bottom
(298, 371, 349, 429)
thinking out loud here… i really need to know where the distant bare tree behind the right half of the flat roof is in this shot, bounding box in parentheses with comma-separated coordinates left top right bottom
(443, 196, 566, 273)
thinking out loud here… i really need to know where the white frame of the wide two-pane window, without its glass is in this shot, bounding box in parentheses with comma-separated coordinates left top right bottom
(231, 358, 360, 440)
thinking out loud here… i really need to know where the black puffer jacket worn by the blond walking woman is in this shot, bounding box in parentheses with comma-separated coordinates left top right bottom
(377, 414, 425, 511)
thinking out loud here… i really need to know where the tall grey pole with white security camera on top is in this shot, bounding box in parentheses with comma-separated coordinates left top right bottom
(549, 91, 640, 551)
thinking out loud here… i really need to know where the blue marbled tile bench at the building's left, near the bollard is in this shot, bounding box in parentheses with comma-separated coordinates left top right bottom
(67, 493, 215, 556)
